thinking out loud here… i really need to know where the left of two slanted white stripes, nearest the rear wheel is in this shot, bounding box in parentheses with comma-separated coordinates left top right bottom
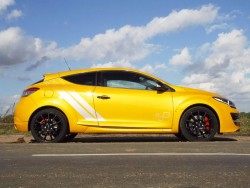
(58, 91, 96, 121)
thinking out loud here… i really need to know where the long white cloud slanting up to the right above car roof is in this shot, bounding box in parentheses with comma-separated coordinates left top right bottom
(49, 5, 218, 62)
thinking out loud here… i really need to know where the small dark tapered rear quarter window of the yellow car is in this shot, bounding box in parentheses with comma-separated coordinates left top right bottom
(63, 72, 96, 86)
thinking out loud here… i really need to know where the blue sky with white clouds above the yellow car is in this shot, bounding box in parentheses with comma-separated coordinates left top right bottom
(0, 0, 250, 115)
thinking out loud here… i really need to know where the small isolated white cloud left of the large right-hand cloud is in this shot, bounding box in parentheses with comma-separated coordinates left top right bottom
(169, 47, 192, 66)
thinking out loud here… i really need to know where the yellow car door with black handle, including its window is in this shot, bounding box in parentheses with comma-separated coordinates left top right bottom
(94, 71, 173, 128)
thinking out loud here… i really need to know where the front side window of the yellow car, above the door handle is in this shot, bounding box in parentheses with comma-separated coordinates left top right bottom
(102, 71, 162, 90)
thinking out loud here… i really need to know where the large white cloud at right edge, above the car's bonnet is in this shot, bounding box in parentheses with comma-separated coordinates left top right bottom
(182, 30, 250, 110)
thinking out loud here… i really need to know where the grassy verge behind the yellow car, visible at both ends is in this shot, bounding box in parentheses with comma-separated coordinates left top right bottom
(0, 117, 250, 136)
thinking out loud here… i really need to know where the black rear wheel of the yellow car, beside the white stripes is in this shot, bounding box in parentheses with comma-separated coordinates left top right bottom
(30, 108, 68, 142)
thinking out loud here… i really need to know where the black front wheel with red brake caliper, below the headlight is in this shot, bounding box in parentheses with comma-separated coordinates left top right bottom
(180, 106, 219, 141)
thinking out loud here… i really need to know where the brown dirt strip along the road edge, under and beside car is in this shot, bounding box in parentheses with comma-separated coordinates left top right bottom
(0, 134, 250, 144)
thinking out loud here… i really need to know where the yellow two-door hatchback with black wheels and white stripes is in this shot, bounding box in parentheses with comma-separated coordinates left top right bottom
(14, 68, 240, 142)
